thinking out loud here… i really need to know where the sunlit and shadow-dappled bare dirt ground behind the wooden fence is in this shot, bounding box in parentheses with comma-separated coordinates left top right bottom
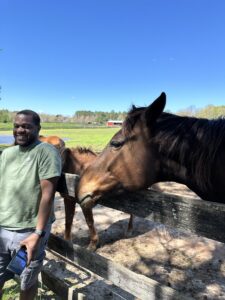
(53, 183, 225, 299)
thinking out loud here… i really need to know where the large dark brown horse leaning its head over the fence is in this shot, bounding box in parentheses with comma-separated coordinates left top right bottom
(77, 92, 225, 207)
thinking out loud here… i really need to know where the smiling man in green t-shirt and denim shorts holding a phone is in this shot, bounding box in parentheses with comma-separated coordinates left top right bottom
(0, 110, 61, 300)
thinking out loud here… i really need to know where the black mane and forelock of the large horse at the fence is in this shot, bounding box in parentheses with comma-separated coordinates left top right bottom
(123, 106, 225, 190)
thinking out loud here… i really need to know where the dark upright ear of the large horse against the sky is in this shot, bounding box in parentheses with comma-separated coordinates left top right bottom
(145, 92, 166, 126)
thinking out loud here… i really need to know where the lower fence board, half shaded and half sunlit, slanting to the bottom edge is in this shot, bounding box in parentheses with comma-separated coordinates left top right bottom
(48, 234, 192, 300)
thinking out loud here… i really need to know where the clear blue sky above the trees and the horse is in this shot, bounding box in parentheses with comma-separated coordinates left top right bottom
(0, 0, 225, 115)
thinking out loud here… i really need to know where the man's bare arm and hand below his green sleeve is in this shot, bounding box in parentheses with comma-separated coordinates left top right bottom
(20, 177, 59, 265)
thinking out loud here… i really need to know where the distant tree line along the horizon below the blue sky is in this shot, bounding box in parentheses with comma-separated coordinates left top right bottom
(0, 105, 225, 125)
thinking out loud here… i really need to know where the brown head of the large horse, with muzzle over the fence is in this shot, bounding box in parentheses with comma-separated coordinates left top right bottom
(78, 93, 166, 206)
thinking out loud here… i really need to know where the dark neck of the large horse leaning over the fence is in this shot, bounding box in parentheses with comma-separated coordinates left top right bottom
(152, 117, 225, 201)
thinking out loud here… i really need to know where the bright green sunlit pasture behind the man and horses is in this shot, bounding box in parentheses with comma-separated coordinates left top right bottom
(0, 127, 119, 151)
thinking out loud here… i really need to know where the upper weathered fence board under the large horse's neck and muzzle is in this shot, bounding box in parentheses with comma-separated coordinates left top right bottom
(55, 174, 225, 243)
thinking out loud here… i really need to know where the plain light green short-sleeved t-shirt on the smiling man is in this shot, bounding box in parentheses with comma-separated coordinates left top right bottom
(0, 141, 61, 230)
